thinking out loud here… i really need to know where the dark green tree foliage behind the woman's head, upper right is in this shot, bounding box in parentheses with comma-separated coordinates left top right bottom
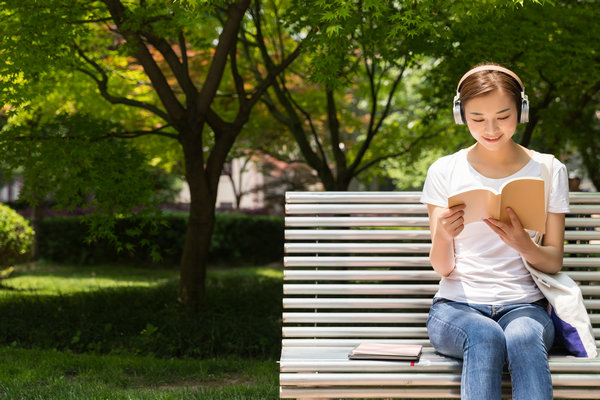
(427, 1, 600, 187)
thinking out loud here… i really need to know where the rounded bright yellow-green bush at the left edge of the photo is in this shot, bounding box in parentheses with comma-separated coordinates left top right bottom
(0, 204, 34, 267)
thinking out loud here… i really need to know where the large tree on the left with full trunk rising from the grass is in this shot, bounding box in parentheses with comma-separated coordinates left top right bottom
(0, 0, 301, 308)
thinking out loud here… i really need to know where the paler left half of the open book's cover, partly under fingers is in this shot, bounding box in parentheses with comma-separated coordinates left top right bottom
(448, 189, 500, 225)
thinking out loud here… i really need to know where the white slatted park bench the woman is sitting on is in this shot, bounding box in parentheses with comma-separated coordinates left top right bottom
(280, 192, 600, 399)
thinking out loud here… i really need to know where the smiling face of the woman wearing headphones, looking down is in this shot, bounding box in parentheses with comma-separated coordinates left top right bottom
(464, 89, 517, 151)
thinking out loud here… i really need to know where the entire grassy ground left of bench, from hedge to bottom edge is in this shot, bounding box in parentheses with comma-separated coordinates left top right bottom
(0, 263, 282, 400)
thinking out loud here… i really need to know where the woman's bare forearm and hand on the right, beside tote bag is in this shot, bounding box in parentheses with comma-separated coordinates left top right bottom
(485, 208, 565, 274)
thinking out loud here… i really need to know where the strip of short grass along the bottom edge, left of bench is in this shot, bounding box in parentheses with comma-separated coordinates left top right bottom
(0, 347, 279, 400)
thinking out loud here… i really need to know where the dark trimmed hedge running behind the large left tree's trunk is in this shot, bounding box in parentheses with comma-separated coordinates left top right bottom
(39, 213, 283, 266)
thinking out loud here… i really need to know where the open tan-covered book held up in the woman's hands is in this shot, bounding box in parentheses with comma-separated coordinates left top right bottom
(448, 177, 546, 233)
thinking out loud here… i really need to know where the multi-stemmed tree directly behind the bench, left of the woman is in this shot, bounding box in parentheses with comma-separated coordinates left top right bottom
(243, 0, 528, 190)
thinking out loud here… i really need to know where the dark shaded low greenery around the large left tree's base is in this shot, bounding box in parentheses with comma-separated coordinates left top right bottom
(0, 266, 282, 359)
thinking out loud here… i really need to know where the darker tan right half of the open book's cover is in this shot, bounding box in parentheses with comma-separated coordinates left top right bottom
(500, 178, 546, 233)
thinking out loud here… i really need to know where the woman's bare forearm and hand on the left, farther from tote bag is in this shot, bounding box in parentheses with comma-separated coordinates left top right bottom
(427, 204, 465, 276)
